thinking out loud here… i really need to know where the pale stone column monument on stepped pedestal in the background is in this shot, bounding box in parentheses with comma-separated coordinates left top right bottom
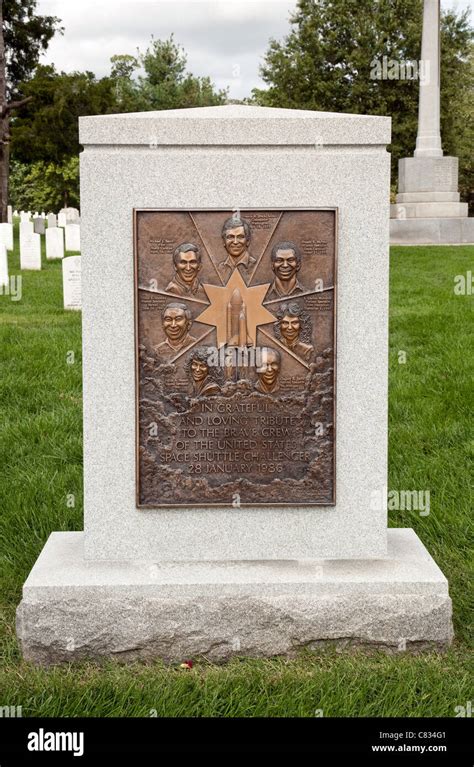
(390, 0, 474, 245)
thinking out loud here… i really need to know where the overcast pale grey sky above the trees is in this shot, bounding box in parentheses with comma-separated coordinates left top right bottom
(38, 0, 474, 98)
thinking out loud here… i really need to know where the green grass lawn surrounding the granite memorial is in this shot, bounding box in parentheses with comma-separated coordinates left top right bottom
(0, 226, 474, 717)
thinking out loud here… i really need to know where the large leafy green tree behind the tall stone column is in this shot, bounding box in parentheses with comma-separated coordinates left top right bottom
(253, 0, 472, 194)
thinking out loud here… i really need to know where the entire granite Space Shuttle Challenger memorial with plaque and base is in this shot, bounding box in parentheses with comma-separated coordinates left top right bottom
(14, 106, 452, 663)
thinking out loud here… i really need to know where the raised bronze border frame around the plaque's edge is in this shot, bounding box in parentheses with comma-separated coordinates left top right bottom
(132, 210, 339, 513)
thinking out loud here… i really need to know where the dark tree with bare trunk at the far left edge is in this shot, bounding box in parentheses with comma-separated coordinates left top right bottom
(0, 0, 59, 221)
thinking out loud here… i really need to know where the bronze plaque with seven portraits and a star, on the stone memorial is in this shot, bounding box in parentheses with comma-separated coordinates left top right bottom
(134, 209, 336, 508)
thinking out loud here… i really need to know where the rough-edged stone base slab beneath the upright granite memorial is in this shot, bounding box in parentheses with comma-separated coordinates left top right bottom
(17, 529, 452, 664)
